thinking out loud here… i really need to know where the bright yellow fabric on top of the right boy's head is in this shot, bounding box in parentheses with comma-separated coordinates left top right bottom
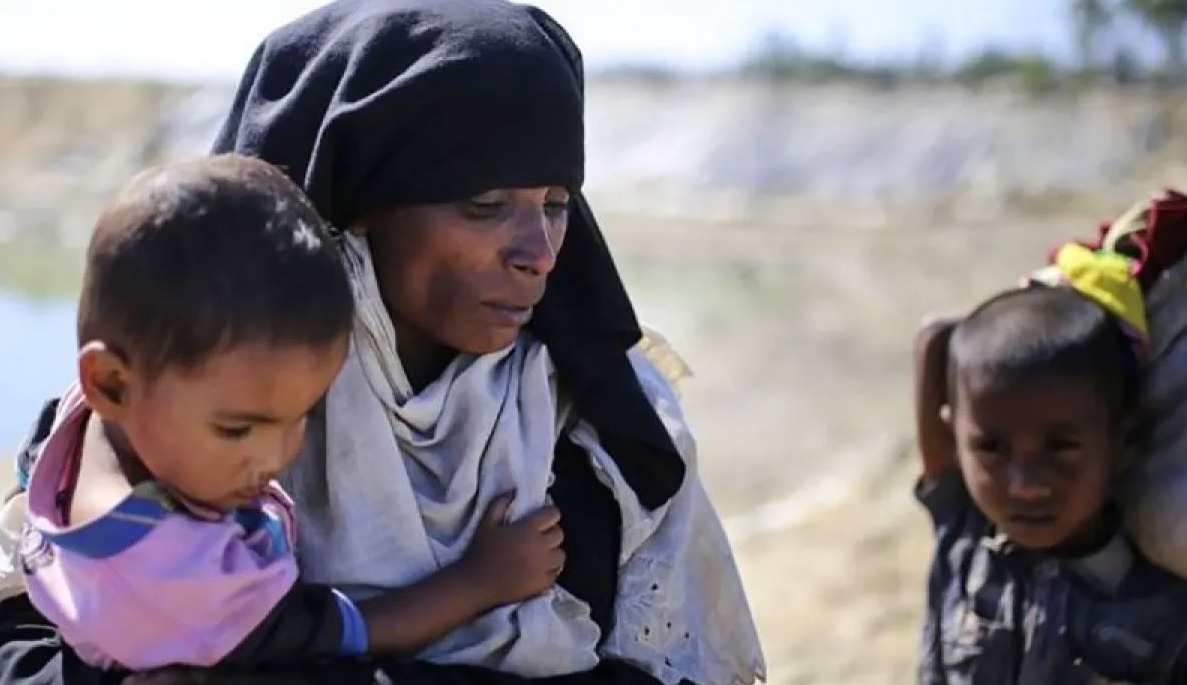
(1036, 243, 1149, 338)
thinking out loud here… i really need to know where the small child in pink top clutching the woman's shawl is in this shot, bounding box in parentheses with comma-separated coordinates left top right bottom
(20, 156, 564, 671)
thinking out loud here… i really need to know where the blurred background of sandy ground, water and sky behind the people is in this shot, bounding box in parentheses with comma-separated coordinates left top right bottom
(0, 0, 1187, 684)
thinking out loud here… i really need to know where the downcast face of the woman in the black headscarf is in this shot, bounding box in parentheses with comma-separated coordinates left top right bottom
(361, 188, 569, 362)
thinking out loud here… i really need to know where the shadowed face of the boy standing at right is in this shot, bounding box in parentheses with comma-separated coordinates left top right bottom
(952, 373, 1124, 550)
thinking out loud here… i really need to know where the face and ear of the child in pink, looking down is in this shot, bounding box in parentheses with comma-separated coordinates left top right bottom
(80, 337, 348, 512)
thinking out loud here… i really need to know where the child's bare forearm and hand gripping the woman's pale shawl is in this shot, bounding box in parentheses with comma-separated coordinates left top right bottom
(348, 496, 565, 657)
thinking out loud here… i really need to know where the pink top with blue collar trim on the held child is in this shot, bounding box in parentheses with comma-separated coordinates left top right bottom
(20, 387, 308, 671)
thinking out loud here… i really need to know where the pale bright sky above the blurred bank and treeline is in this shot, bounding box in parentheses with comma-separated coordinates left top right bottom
(0, 0, 1149, 80)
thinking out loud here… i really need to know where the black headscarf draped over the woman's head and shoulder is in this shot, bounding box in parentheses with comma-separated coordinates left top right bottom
(214, 0, 685, 508)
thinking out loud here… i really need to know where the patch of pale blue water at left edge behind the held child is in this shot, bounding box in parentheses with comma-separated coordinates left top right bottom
(0, 291, 77, 456)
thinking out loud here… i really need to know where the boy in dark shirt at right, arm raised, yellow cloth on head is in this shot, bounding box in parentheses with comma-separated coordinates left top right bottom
(915, 246, 1187, 685)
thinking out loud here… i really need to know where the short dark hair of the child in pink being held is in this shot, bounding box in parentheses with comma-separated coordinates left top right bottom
(78, 154, 354, 376)
